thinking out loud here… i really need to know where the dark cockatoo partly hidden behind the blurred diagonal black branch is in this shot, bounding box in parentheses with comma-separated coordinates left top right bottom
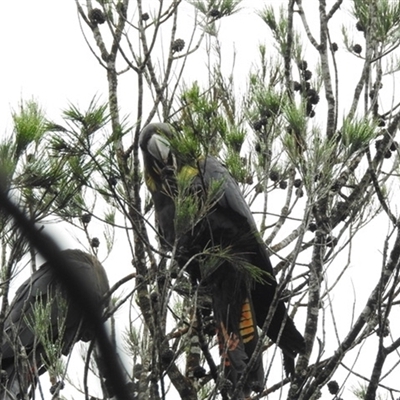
(0, 250, 109, 399)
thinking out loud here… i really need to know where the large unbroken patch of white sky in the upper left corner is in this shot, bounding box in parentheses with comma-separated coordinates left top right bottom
(0, 0, 105, 128)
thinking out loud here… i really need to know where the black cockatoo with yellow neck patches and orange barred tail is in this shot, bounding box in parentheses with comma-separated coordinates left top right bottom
(139, 123, 305, 395)
